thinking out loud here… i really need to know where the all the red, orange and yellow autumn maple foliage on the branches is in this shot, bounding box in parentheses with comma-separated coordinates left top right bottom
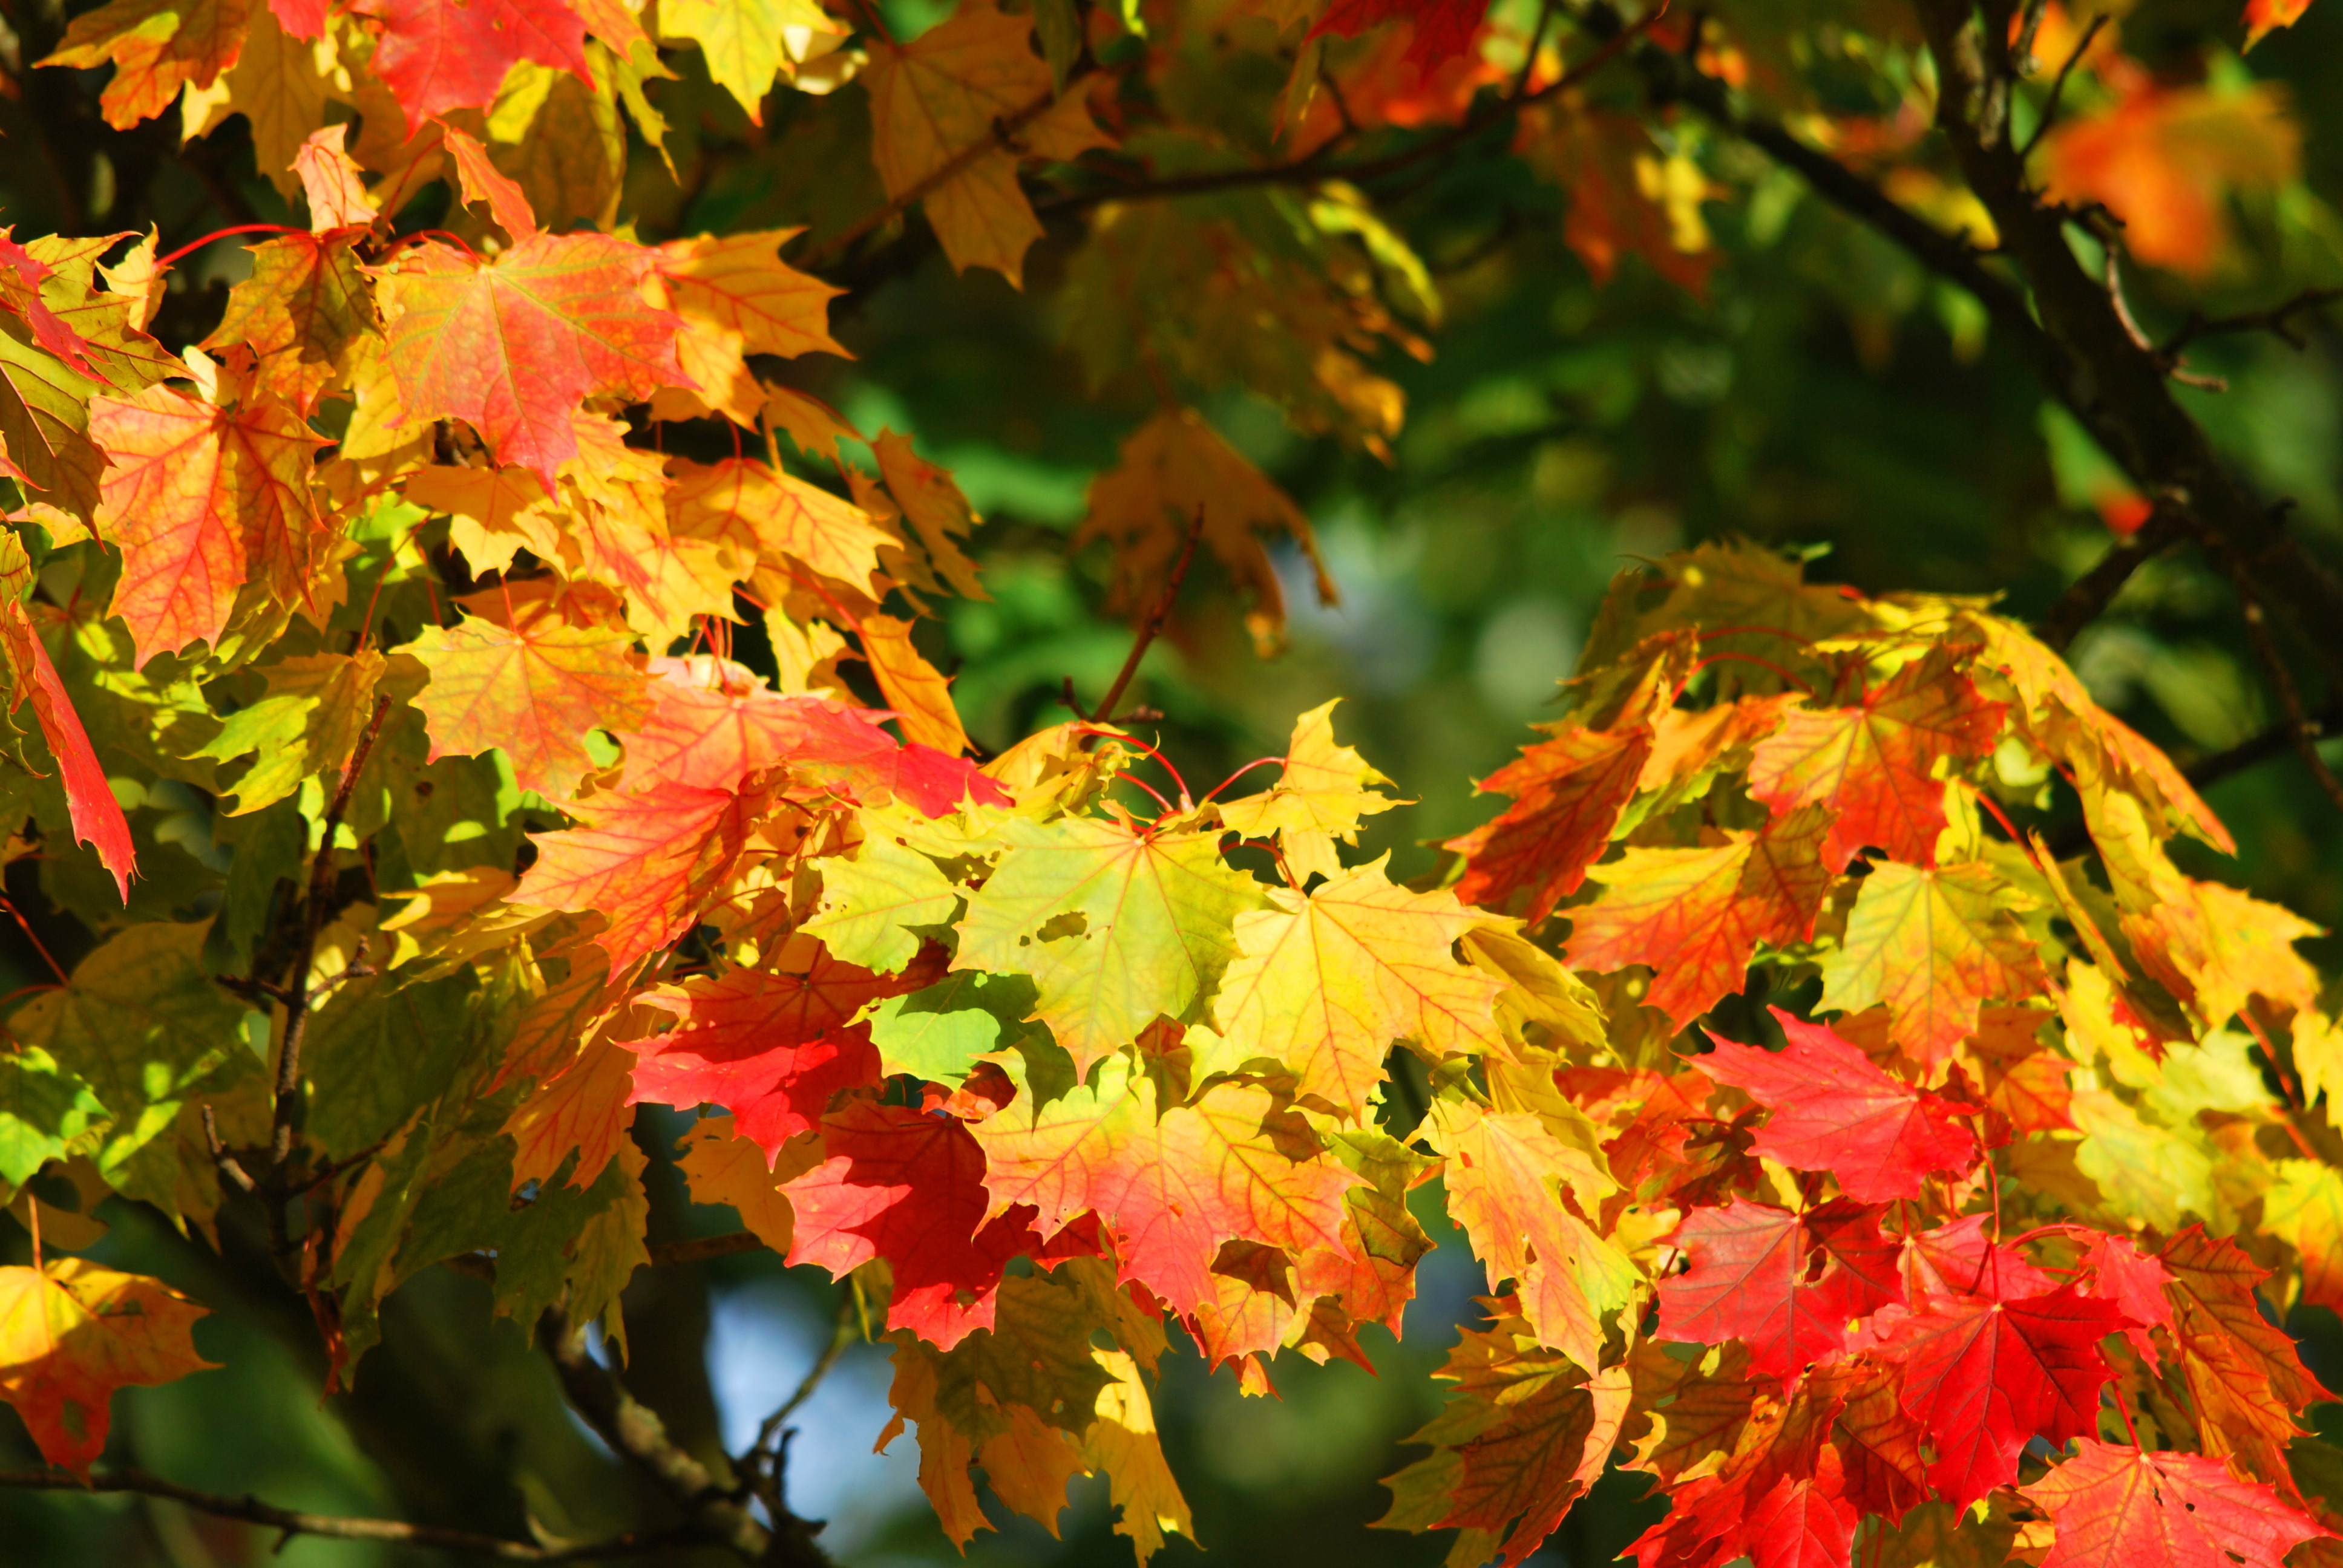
(0, 0, 2343, 1568)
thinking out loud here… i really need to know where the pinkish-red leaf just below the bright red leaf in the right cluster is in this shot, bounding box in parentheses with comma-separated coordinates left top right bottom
(1659, 1198, 1879, 1378)
